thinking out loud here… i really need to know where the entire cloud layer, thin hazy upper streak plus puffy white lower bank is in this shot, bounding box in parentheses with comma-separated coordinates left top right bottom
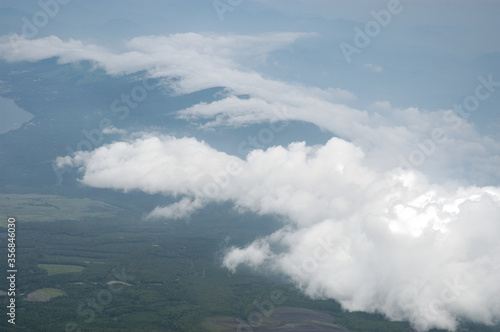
(0, 33, 500, 331)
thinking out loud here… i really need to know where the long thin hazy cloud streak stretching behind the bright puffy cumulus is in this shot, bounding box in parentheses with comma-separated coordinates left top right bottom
(0, 33, 500, 184)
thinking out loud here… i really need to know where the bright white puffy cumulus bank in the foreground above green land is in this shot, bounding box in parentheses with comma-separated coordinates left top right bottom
(59, 136, 500, 331)
